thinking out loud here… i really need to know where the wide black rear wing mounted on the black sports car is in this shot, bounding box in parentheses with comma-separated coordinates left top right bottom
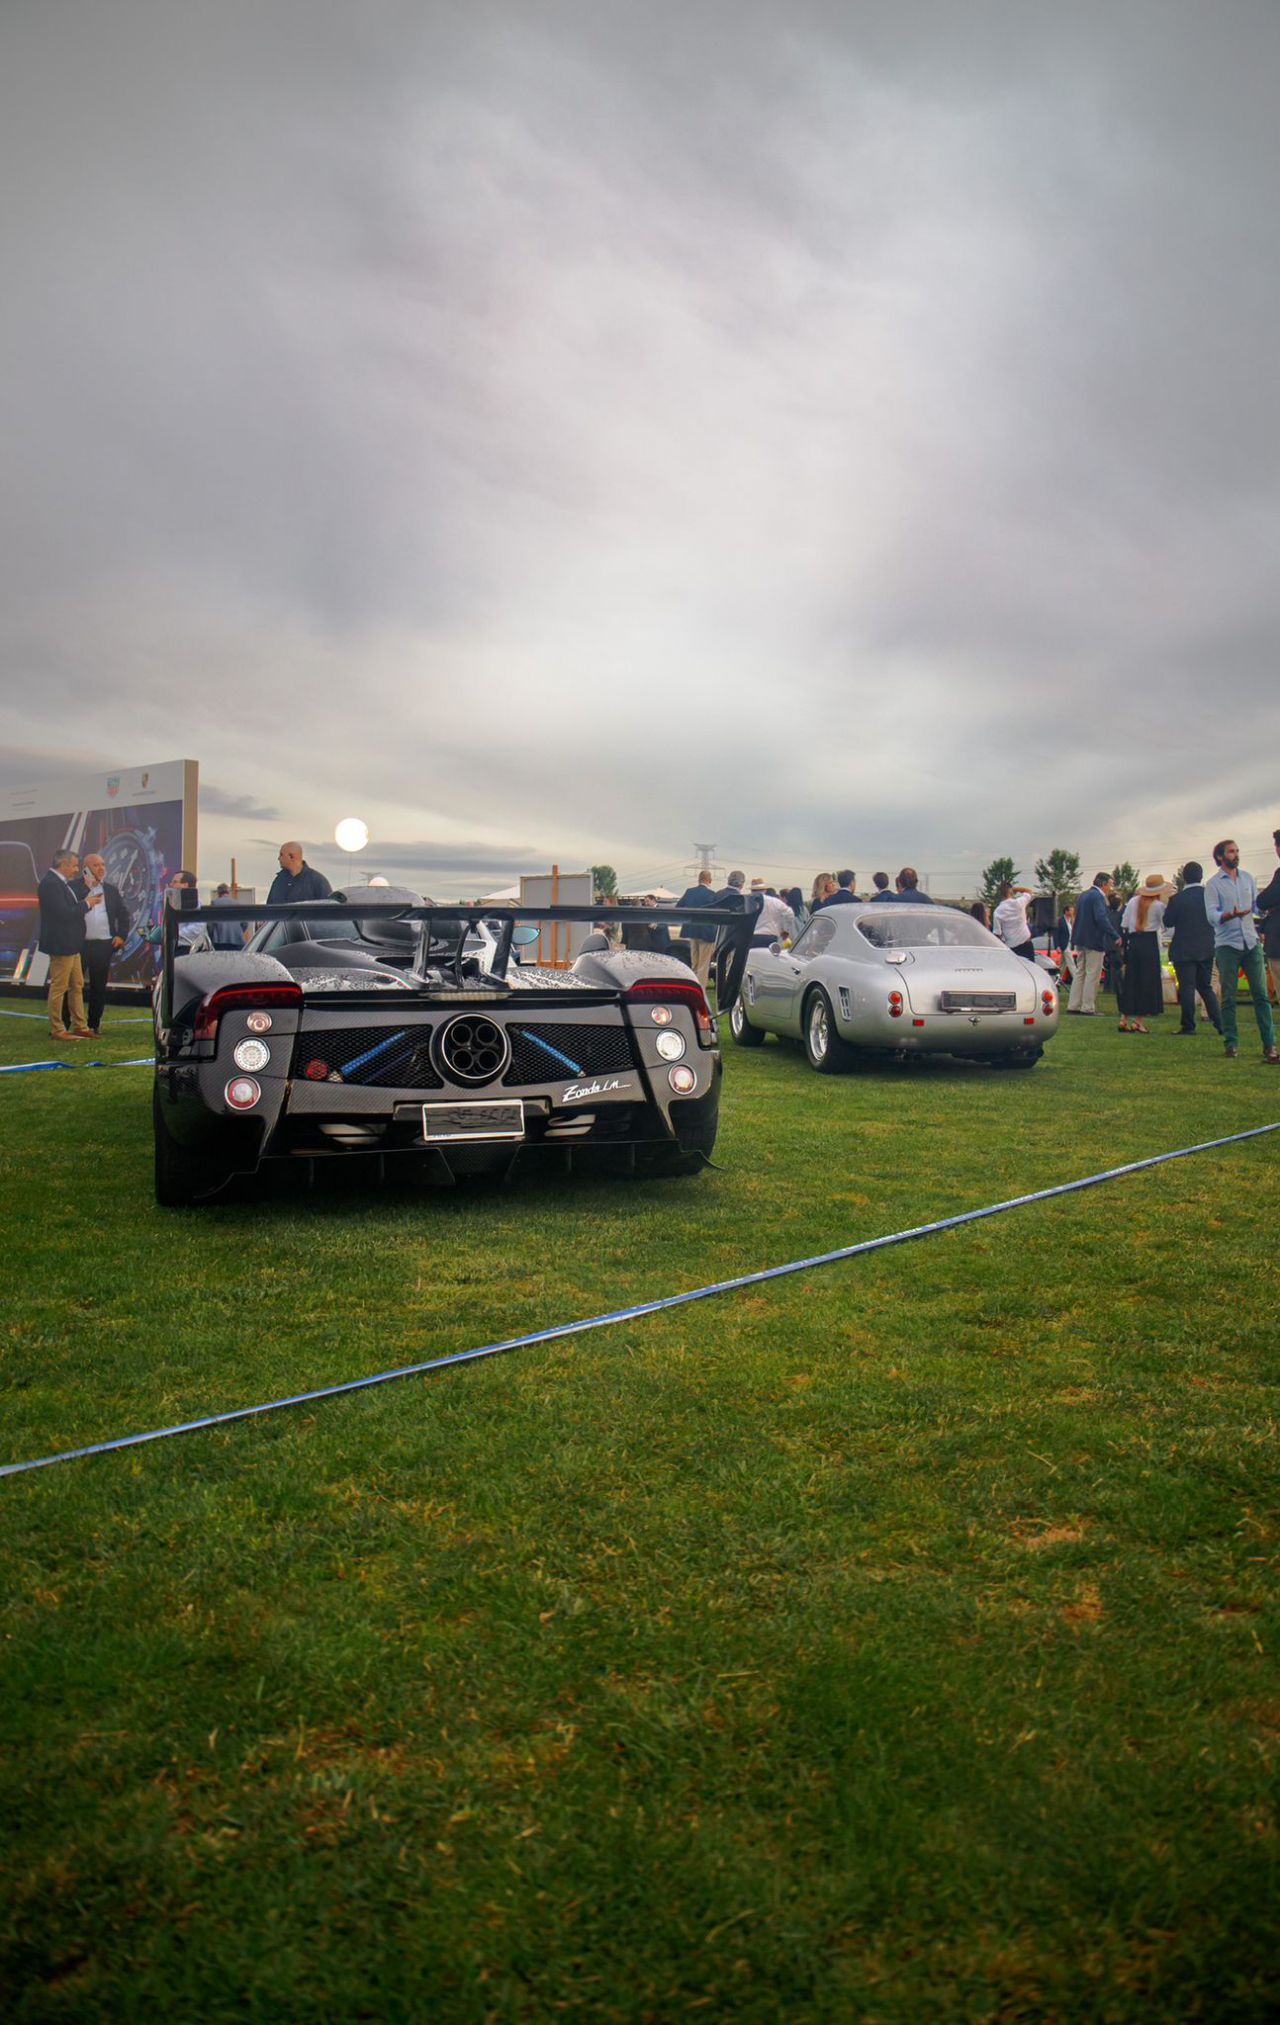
(160, 889, 764, 1027)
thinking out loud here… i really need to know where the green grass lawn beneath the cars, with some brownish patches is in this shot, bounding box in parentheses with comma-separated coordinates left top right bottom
(0, 992, 1280, 2025)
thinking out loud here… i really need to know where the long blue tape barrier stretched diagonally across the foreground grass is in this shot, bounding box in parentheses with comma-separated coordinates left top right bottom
(0, 1120, 1280, 1476)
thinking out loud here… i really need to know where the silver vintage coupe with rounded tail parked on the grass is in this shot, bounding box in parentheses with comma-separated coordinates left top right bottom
(729, 901, 1057, 1075)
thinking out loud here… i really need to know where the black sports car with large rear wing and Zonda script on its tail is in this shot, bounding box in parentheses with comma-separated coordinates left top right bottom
(154, 889, 757, 1207)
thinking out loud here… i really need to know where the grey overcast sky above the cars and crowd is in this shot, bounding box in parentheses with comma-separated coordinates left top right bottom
(0, 0, 1280, 893)
